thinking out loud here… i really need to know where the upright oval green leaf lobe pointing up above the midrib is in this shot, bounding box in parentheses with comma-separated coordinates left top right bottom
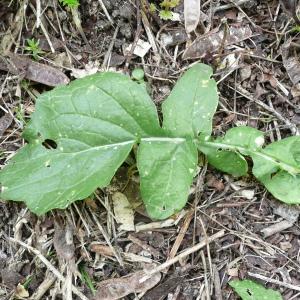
(162, 64, 218, 137)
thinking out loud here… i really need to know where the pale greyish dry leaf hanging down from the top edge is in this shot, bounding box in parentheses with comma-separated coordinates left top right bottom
(184, 0, 200, 33)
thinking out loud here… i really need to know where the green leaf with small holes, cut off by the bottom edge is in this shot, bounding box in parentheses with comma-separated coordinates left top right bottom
(229, 280, 283, 300)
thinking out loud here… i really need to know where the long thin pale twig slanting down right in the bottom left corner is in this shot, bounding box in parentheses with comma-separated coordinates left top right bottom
(9, 238, 89, 300)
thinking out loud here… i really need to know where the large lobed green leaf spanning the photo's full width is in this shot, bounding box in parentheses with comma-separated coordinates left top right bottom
(0, 64, 300, 219)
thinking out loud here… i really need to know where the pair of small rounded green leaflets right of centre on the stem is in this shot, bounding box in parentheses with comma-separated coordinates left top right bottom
(198, 126, 264, 177)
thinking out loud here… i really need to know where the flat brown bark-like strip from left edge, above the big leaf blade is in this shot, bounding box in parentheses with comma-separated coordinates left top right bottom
(0, 53, 70, 86)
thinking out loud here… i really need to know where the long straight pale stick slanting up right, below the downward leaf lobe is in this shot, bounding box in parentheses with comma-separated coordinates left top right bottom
(140, 230, 224, 282)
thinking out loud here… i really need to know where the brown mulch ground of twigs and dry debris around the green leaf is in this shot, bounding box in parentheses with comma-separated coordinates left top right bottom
(0, 0, 300, 300)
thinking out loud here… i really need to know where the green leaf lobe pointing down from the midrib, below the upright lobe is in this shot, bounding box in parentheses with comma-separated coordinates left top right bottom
(137, 138, 198, 219)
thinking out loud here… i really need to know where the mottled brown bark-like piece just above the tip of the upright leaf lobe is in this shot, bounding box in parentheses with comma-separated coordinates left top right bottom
(183, 25, 253, 59)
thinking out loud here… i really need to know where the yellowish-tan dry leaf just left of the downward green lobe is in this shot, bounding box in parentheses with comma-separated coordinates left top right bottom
(112, 192, 134, 231)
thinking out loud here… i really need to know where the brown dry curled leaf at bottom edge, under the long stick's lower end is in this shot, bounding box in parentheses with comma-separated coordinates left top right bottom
(93, 271, 161, 300)
